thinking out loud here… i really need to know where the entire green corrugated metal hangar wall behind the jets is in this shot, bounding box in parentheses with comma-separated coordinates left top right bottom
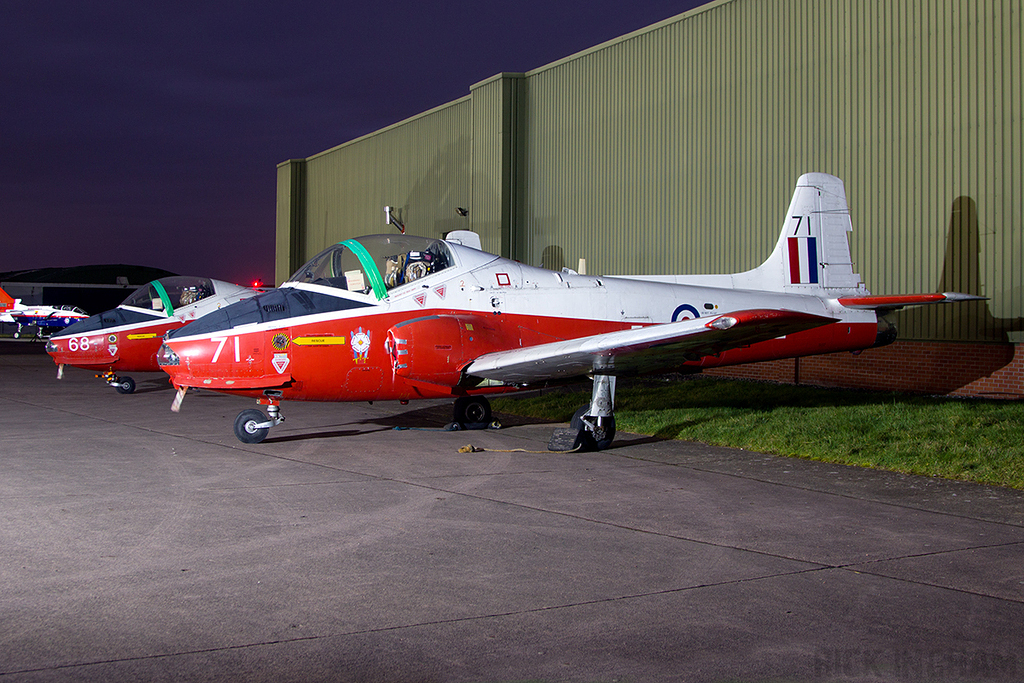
(276, 0, 1024, 394)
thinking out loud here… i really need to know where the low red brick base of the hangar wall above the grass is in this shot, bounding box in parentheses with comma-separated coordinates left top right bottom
(703, 341, 1024, 398)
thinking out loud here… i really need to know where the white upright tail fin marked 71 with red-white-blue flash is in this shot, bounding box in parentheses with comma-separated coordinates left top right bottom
(733, 173, 866, 297)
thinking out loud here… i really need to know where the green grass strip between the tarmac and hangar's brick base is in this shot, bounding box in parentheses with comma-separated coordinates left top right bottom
(492, 377, 1024, 488)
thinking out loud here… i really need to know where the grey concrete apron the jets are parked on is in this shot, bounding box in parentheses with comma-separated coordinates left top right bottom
(0, 353, 1024, 681)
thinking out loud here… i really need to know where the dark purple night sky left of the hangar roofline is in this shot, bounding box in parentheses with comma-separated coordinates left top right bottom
(0, 0, 702, 282)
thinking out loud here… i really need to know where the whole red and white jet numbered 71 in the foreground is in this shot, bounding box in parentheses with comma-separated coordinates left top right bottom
(158, 173, 981, 450)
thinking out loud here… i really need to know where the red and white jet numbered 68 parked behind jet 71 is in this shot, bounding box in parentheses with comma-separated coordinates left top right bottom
(46, 275, 266, 393)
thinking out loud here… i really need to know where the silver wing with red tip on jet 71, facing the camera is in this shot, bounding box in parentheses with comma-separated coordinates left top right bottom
(463, 309, 836, 384)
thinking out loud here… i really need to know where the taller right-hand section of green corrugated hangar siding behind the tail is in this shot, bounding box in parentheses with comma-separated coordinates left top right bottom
(523, 0, 1024, 340)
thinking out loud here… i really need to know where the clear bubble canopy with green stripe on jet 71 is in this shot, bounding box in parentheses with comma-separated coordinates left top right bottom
(289, 234, 452, 300)
